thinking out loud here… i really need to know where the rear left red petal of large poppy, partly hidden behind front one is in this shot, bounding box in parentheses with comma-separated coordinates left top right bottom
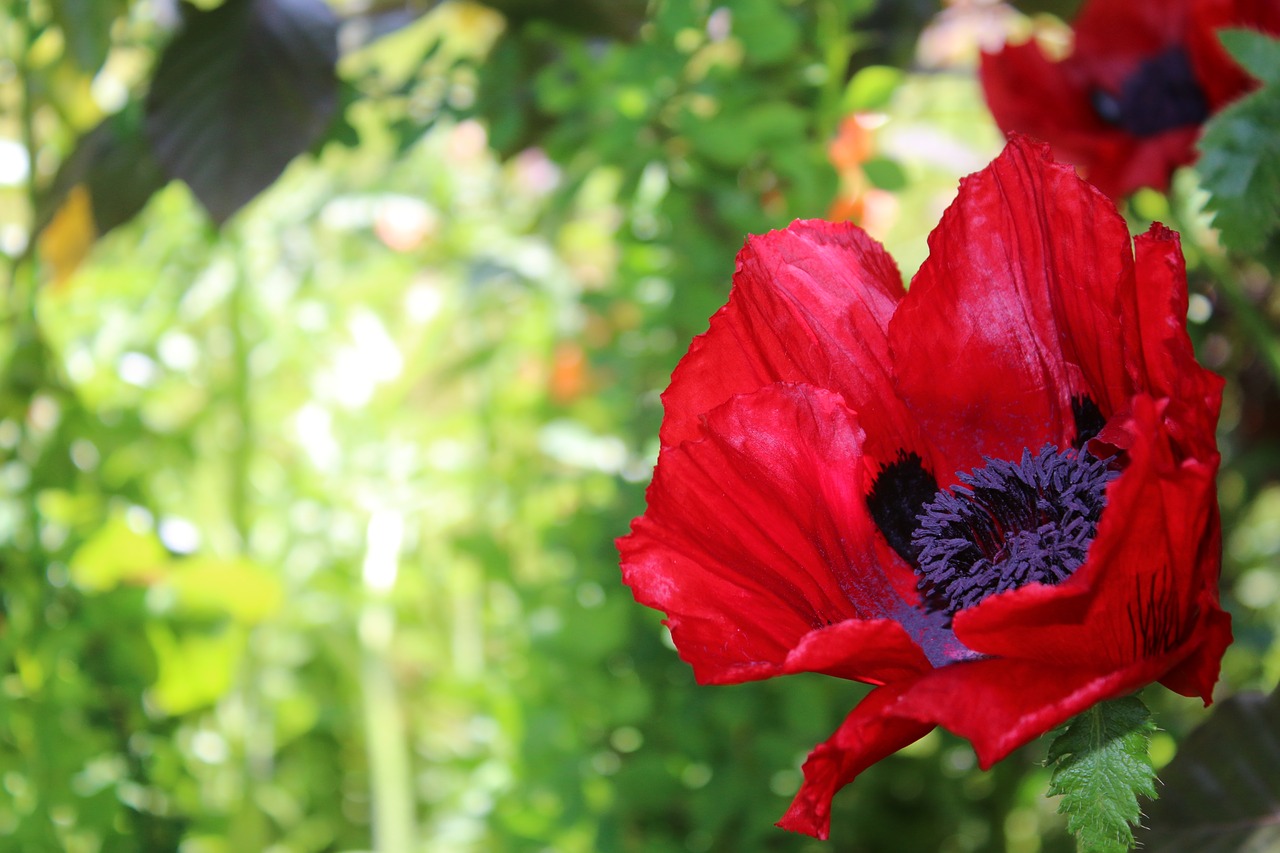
(662, 220, 927, 465)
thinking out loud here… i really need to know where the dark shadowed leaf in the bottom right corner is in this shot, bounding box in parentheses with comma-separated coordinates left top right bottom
(1138, 692, 1280, 853)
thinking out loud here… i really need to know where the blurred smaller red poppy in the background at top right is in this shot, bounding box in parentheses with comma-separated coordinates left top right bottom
(982, 0, 1280, 199)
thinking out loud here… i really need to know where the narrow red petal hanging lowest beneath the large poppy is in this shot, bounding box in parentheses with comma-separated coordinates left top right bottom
(778, 681, 933, 840)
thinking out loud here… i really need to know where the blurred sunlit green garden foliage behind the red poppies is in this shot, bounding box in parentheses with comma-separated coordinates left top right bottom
(0, 0, 1280, 853)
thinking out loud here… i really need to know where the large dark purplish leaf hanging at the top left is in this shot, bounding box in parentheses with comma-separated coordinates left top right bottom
(146, 0, 338, 224)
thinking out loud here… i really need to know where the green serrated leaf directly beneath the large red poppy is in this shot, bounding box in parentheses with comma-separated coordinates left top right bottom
(1048, 697, 1156, 853)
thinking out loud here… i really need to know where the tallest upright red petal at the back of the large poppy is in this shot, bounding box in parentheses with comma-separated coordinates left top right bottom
(890, 137, 1132, 480)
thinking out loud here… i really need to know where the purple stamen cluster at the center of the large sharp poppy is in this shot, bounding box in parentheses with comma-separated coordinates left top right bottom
(911, 444, 1116, 615)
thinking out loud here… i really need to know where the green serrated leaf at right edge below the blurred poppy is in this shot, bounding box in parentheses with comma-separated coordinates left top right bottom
(1197, 60, 1280, 254)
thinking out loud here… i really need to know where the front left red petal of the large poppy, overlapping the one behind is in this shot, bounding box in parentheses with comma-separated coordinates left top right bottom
(618, 384, 928, 683)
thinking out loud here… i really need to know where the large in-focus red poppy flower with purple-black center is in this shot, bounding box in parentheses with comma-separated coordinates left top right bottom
(618, 137, 1231, 838)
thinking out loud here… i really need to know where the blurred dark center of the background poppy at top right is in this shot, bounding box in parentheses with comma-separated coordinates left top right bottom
(1093, 47, 1208, 137)
